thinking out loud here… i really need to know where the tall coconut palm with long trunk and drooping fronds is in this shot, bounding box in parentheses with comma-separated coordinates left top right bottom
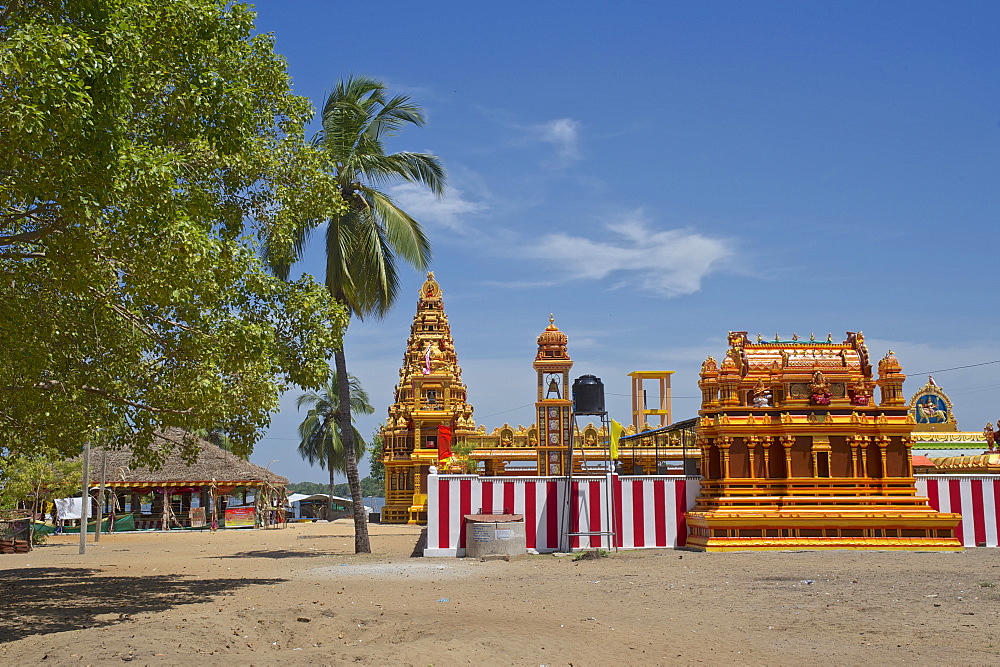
(274, 76, 445, 553)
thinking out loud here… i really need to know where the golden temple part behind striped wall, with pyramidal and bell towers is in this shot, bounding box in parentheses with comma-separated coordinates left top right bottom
(382, 273, 668, 523)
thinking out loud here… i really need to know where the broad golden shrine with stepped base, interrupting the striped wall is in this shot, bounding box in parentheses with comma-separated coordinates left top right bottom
(685, 331, 962, 551)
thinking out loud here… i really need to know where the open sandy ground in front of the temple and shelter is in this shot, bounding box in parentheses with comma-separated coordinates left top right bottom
(0, 520, 1000, 665)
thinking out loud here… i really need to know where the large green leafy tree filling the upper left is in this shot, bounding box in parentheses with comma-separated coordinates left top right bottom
(0, 0, 347, 465)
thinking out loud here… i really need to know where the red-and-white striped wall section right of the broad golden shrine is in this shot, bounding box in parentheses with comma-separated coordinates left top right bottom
(917, 475, 1000, 547)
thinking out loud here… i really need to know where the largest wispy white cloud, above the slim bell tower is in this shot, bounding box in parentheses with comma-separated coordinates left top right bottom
(529, 210, 733, 297)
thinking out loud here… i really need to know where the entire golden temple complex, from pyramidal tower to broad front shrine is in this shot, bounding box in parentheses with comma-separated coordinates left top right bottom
(382, 273, 964, 551)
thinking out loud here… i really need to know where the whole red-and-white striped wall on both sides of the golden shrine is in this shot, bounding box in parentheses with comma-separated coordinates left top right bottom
(424, 475, 1000, 557)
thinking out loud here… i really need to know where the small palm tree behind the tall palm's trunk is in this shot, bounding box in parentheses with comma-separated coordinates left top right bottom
(295, 373, 375, 517)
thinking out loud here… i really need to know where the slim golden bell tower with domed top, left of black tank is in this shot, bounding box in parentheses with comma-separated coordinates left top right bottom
(532, 314, 573, 475)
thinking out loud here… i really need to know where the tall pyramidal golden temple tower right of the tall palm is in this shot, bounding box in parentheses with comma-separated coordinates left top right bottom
(382, 273, 475, 523)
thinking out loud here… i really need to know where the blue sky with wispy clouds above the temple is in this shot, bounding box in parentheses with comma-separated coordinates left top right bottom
(242, 0, 1000, 481)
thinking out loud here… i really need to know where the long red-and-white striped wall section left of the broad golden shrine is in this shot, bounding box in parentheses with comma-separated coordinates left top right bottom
(424, 475, 699, 557)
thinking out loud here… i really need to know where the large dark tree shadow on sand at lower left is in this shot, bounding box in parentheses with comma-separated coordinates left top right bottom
(0, 567, 288, 643)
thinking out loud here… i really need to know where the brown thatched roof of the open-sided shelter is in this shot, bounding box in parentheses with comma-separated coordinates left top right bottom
(77, 429, 288, 487)
